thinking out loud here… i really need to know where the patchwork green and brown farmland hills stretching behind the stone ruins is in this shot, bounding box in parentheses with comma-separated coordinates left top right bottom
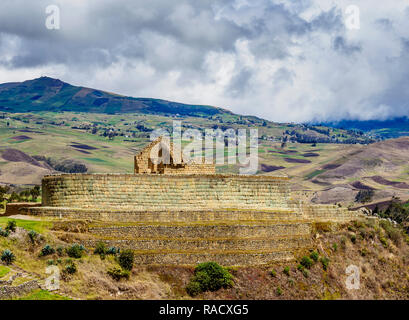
(0, 112, 409, 205)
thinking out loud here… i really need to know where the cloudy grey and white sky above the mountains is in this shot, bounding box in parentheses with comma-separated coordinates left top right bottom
(0, 0, 409, 122)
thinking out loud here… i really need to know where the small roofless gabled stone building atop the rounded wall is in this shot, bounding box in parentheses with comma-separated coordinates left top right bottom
(134, 136, 216, 174)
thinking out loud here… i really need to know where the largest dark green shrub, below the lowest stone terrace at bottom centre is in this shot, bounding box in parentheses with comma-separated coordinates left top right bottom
(186, 262, 233, 294)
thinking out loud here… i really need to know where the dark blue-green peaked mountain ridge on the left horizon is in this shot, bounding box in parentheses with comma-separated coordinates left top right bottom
(0, 77, 232, 116)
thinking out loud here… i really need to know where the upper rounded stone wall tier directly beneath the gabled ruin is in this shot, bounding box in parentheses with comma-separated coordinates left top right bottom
(42, 174, 290, 210)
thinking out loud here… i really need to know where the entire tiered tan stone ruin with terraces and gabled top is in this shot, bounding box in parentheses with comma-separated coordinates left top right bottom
(20, 137, 358, 265)
